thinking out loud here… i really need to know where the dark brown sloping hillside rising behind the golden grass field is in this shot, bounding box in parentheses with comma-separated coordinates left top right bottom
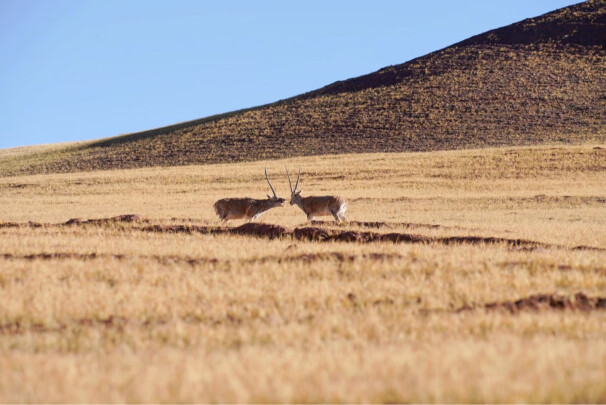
(0, 0, 606, 175)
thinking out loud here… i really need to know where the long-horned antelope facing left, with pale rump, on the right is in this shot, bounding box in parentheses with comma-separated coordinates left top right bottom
(285, 168, 347, 223)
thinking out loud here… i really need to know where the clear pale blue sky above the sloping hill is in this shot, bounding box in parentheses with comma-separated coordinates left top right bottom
(0, 0, 578, 148)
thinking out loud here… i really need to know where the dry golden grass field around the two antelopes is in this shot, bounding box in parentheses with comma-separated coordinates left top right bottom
(0, 144, 606, 403)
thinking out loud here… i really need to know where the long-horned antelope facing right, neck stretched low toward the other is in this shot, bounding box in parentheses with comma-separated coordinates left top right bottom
(214, 167, 286, 223)
